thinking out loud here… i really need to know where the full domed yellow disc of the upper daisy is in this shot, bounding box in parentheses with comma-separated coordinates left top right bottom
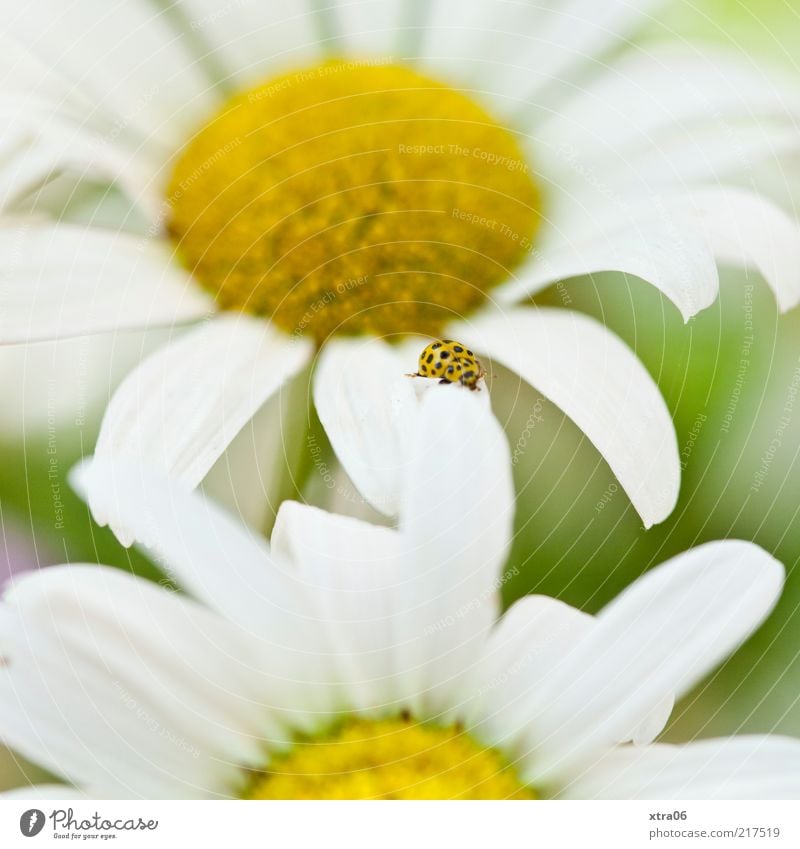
(167, 61, 540, 341)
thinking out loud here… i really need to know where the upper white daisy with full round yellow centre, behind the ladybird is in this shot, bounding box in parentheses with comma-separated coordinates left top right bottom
(0, 0, 800, 526)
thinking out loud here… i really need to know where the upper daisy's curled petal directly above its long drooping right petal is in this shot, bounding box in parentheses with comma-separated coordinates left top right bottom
(495, 197, 719, 321)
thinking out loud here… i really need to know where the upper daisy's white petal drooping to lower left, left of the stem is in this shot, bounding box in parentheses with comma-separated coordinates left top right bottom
(89, 313, 311, 524)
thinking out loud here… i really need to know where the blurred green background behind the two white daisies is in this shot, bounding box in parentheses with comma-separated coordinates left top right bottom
(0, 0, 800, 787)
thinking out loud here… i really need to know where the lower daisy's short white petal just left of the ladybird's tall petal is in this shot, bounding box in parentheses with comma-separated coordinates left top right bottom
(272, 501, 404, 711)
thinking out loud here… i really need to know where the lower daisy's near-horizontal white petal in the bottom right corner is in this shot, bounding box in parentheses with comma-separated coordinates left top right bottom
(562, 735, 800, 800)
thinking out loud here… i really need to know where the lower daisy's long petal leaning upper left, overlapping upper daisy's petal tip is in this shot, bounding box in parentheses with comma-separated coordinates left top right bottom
(70, 460, 333, 725)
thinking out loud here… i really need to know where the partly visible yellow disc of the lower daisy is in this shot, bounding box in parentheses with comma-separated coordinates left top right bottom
(245, 719, 536, 799)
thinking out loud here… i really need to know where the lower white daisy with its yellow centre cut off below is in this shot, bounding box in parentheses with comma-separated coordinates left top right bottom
(0, 390, 800, 799)
